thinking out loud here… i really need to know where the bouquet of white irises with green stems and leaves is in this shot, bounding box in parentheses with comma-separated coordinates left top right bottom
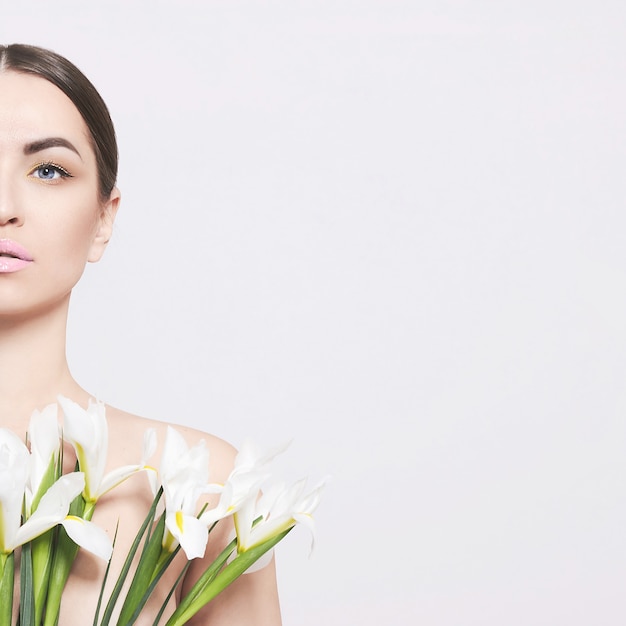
(0, 397, 323, 626)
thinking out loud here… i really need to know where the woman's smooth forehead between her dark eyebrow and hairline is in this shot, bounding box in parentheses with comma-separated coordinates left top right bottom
(0, 71, 89, 147)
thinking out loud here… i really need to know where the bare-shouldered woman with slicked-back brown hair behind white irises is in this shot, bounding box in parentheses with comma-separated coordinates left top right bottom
(0, 45, 280, 626)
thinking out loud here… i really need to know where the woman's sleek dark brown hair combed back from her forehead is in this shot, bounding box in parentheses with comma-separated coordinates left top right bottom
(0, 44, 118, 200)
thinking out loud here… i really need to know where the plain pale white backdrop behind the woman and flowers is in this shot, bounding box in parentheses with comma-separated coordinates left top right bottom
(0, 0, 626, 626)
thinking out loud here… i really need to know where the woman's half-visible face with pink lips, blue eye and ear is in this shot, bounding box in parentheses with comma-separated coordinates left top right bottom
(0, 71, 119, 316)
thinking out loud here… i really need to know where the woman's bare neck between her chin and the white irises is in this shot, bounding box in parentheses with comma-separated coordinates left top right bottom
(0, 298, 85, 434)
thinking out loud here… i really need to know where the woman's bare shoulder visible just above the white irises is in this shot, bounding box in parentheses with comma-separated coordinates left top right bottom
(106, 405, 237, 482)
